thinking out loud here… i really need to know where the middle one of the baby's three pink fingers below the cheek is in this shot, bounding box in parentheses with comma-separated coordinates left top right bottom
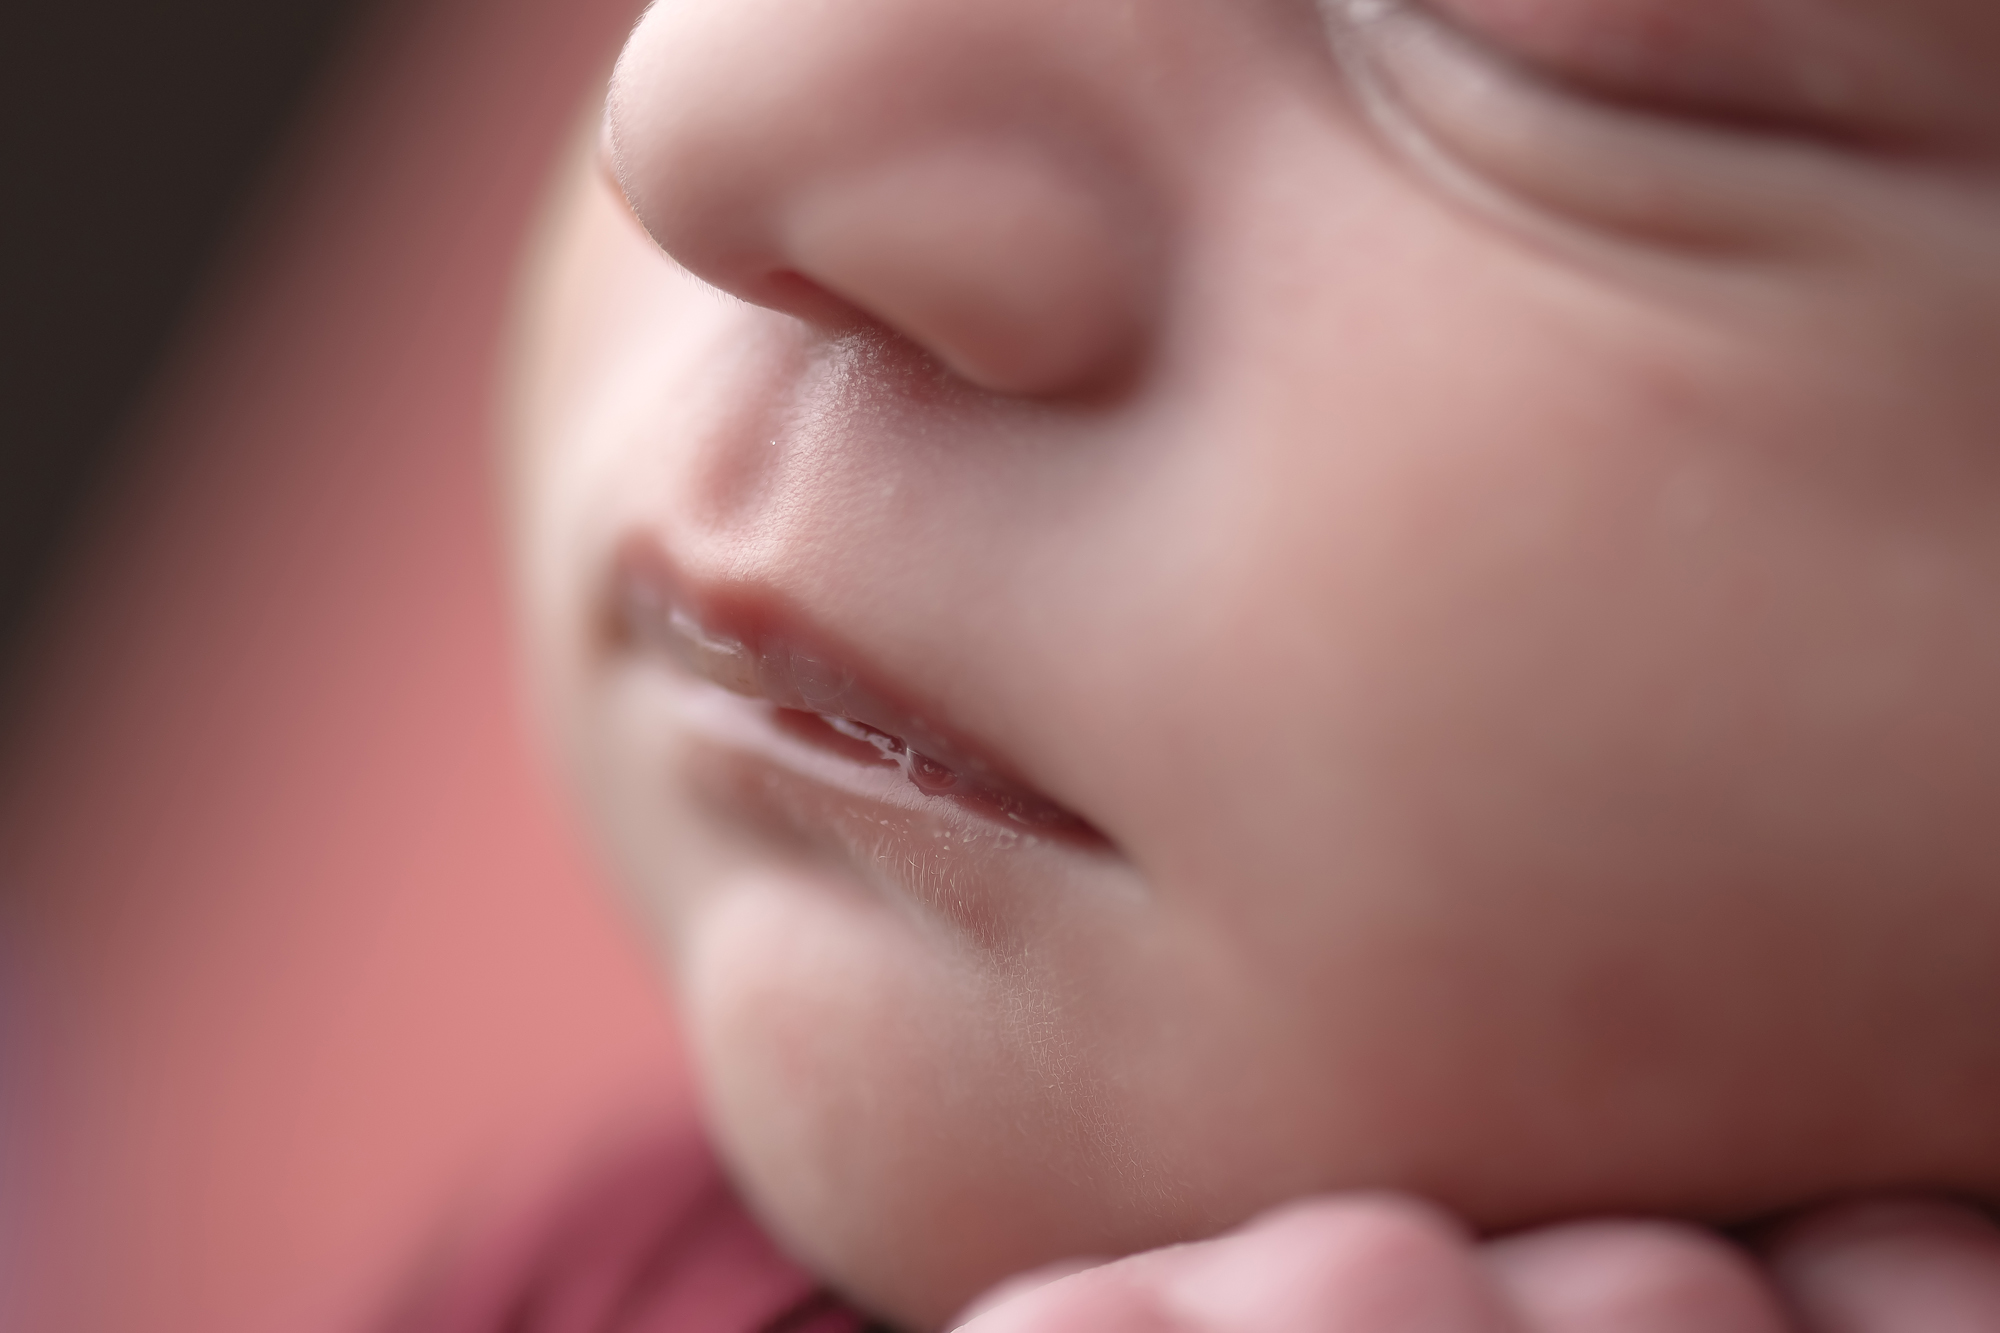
(1486, 1221, 1790, 1333)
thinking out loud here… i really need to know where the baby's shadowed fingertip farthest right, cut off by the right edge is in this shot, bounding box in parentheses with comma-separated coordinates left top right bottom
(1770, 1199, 2000, 1333)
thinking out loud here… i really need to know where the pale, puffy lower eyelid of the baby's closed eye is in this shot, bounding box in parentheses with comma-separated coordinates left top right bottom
(1320, 0, 1912, 254)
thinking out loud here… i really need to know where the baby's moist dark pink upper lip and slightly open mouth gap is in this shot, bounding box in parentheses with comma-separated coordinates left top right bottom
(608, 538, 1104, 845)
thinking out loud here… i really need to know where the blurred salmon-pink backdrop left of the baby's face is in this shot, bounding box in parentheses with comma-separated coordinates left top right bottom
(0, 0, 736, 1333)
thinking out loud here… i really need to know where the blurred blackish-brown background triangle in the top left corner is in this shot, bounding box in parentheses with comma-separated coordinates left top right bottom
(0, 0, 360, 677)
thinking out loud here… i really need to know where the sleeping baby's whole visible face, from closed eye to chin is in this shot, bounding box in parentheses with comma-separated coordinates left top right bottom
(516, 0, 2000, 1325)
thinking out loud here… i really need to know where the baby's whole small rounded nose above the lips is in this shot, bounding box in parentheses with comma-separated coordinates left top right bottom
(606, 0, 1164, 394)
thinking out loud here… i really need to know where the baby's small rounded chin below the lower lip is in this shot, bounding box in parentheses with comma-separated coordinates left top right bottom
(682, 885, 1160, 1329)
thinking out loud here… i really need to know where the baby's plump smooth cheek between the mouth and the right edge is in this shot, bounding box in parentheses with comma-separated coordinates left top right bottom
(1168, 244, 1996, 1221)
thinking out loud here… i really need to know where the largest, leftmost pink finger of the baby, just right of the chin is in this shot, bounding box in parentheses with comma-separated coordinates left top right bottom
(964, 1197, 1520, 1333)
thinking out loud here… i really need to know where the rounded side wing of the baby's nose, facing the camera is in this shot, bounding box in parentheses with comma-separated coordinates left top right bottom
(778, 144, 1154, 394)
